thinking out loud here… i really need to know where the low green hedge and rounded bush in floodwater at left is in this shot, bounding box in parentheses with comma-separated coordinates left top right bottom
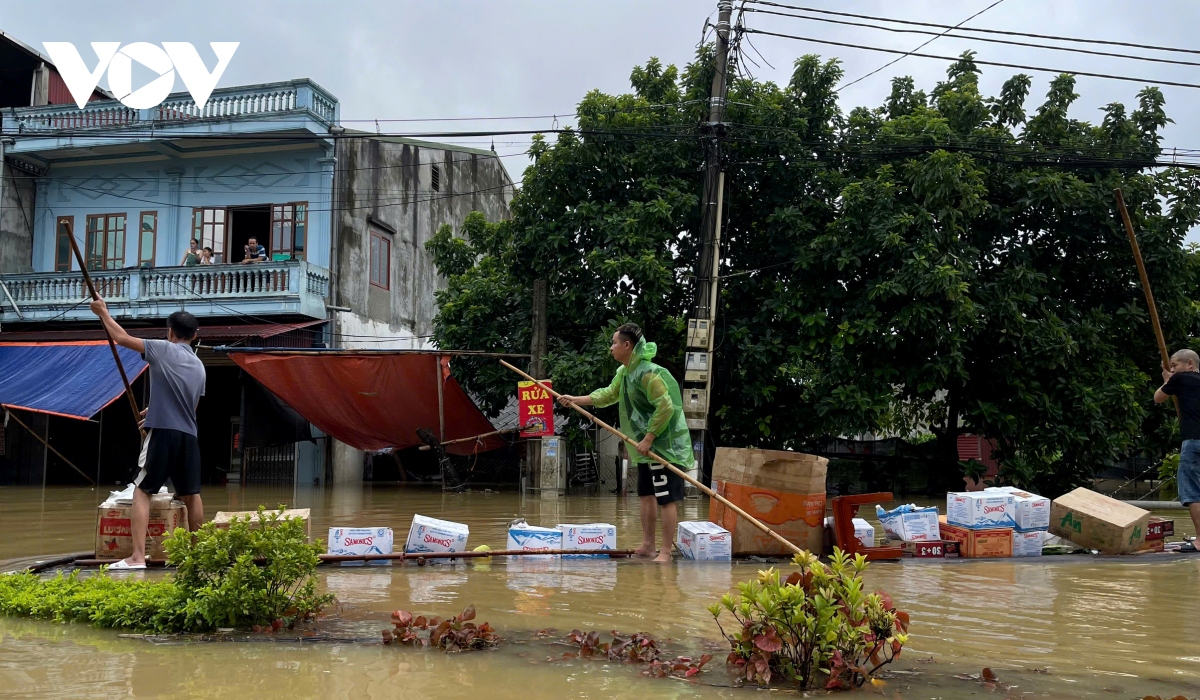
(0, 507, 334, 633)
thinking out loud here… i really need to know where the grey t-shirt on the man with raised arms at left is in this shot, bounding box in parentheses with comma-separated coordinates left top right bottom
(143, 340, 204, 435)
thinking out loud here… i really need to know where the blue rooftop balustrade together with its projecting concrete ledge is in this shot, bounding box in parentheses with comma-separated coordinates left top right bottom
(4, 78, 338, 155)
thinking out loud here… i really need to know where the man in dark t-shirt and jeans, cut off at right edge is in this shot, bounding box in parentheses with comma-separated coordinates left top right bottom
(1154, 349, 1200, 552)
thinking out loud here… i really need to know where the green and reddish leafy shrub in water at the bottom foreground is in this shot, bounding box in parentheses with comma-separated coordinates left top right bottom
(708, 549, 908, 689)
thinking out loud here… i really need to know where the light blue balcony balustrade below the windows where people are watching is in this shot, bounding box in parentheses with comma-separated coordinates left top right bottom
(0, 261, 330, 323)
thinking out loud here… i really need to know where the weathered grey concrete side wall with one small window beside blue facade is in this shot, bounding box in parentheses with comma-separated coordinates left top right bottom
(330, 138, 512, 348)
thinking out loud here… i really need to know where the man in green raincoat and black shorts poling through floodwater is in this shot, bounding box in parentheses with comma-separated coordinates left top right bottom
(559, 323, 695, 562)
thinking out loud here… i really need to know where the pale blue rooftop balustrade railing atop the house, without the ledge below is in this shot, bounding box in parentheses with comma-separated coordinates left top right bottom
(4, 79, 337, 133)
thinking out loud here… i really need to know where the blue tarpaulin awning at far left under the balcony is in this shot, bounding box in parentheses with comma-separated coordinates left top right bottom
(0, 341, 146, 420)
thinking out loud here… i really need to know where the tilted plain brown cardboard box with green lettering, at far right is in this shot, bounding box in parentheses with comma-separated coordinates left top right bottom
(1050, 486, 1150, 555)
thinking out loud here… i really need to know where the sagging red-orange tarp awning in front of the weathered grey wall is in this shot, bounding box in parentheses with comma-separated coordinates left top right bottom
(229, 349, 504, 455)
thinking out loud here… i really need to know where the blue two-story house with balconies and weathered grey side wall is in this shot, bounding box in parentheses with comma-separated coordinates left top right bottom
(0, 35, 512, 484)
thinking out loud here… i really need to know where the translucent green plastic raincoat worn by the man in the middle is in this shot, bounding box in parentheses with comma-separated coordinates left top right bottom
(590, 337, 695, 471)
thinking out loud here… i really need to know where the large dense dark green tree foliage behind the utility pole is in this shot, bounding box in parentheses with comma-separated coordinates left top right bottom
(428, 48, 1200, 493)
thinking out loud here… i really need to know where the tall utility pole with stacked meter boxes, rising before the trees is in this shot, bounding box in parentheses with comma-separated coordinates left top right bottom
(683, 0, 733, 480)
